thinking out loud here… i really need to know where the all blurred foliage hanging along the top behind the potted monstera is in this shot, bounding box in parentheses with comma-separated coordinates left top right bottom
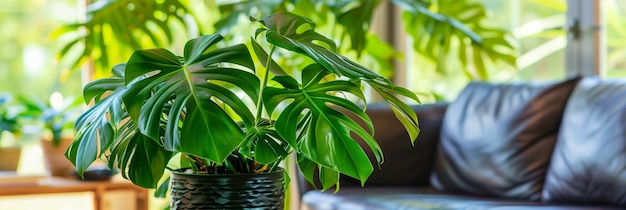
(59, 0, 516, 93)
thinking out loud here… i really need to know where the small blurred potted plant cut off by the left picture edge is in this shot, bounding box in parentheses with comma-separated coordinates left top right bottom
(0, 93, 22, 171)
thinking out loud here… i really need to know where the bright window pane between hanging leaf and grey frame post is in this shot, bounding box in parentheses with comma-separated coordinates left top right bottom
(481, 0, 567, 80)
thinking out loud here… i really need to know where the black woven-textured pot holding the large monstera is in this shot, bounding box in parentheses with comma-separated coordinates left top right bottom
(170, 170, 285, 209)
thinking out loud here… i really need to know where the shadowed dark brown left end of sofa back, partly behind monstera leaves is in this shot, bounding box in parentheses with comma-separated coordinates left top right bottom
(299, 103, 448, 191)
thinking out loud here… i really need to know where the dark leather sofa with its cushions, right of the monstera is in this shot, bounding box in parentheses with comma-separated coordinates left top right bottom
(301, 77, 626, 210)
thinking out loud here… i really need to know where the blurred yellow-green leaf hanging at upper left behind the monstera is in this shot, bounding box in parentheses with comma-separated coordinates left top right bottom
(52, 0, 200, 77)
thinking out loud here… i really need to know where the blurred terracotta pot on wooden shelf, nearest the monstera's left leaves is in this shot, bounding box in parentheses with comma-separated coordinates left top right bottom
(41, 138, 76, 177)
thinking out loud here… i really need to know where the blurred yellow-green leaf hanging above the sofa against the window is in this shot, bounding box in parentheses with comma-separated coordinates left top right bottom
(392, 0, 516, 80)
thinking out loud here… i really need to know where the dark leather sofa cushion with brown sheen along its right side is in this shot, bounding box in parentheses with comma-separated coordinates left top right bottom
(431, 79, 578, 201)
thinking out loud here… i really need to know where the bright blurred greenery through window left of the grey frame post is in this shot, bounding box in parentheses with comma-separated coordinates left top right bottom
(405, 0, 567, 103)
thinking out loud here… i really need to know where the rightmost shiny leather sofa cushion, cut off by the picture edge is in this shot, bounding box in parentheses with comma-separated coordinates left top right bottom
(543, 77, 626, 206)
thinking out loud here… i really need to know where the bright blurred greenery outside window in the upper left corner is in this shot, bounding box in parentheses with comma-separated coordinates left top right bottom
(0, 0, 82, 101)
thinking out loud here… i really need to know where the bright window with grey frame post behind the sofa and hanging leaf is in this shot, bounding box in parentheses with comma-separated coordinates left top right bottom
(406, 0, 626, 103)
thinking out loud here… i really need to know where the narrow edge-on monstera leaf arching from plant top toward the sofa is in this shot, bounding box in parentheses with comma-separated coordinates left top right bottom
(257, 12, 419, 143)
